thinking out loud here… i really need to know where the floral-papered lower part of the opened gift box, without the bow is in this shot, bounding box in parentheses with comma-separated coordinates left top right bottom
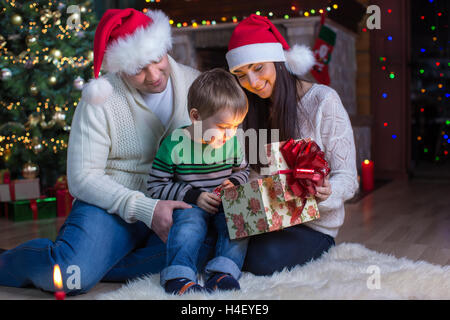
(221, 175, 320, 239)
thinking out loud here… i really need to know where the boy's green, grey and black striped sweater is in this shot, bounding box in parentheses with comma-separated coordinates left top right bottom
(147, 128, 250, 204)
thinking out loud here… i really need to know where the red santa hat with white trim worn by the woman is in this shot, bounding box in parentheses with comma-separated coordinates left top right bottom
(226, 14, 316, 76)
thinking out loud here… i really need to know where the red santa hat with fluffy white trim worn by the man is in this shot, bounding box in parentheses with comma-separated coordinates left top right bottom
(83, 8, 172, 104)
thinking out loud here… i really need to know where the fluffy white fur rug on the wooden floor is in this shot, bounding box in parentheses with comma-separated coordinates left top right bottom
(96, 243, 450, 300)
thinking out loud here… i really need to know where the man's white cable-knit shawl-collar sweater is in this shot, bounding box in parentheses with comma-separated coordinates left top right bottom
(67, 56, 199, 227)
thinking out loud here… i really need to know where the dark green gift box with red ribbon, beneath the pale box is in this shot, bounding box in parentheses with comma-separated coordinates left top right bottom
(7, 198, 56, 222)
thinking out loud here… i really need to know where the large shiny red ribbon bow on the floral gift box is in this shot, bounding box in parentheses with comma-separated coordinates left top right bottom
(278, 139, 331, 199)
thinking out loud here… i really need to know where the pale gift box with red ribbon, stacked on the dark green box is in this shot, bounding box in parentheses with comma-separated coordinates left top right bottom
(0, 178, 41, 202)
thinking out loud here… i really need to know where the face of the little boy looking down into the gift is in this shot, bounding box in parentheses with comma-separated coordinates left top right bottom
(189, 108, 246, 148)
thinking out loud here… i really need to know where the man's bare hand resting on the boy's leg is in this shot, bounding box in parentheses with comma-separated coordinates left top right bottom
(152, 200, 192, 243)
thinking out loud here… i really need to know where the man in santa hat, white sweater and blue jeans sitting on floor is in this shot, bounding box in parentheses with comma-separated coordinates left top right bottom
(0, 9, 213, 294)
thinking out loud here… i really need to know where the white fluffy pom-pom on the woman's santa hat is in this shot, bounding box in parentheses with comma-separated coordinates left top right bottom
(284, 44, 316, 76)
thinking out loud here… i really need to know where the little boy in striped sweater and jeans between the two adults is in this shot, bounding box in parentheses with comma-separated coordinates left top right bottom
(147, 69, 250, 295)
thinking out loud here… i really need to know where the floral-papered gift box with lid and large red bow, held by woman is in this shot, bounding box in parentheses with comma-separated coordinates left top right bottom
(221, 139, 329, 239)
